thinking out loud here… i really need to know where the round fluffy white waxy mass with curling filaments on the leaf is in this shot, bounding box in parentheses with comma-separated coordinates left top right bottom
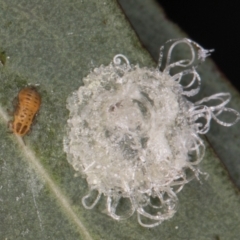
(64, 39, 239, 227)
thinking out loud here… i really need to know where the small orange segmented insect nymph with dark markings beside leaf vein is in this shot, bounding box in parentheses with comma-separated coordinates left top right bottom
(10, 87, 41, 136)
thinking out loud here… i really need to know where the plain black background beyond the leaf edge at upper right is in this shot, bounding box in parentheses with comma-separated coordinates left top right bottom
(156, 0, 240, 92)
